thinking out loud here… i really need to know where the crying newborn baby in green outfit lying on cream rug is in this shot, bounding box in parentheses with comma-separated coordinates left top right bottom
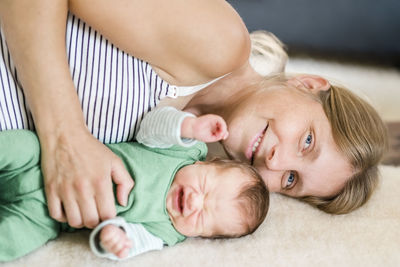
(0, 107, 268, 261)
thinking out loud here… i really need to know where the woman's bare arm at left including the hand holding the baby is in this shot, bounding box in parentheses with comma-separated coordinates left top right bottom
(0, 0, 133, 227)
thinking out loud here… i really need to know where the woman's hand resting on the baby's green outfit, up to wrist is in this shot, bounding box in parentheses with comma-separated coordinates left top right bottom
(42, 131, 134, 228)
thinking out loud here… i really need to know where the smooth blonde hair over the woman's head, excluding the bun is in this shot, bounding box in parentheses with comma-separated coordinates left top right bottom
(301, 85, 388, 214)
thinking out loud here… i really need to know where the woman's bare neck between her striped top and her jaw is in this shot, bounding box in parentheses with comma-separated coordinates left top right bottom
(184, 62, 262, 116)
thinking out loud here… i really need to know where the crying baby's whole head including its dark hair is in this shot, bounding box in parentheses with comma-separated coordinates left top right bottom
(166, 159, 269, 238)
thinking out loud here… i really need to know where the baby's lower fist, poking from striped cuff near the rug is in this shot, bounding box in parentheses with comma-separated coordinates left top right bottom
(100, 224, 132, 259)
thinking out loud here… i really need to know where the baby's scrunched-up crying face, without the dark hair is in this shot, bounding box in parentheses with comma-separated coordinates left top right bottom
(166, 162, 247, 237)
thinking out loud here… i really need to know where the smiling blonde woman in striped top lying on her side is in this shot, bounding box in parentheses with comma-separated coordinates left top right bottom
(0, 0, 386, 228)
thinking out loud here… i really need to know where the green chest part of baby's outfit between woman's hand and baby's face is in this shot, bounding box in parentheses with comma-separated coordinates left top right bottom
(109, 139, 207, 245)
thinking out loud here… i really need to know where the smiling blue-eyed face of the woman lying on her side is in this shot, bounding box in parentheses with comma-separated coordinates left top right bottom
(223, 77, 352, 197)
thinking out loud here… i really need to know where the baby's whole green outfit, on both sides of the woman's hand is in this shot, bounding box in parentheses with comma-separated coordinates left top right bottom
(0, 130, 207, 261)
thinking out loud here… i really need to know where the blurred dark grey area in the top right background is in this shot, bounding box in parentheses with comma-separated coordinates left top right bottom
(228, 0, 400, 66)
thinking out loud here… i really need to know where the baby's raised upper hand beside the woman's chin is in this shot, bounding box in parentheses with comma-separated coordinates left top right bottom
(181, 114, 228, 143)
